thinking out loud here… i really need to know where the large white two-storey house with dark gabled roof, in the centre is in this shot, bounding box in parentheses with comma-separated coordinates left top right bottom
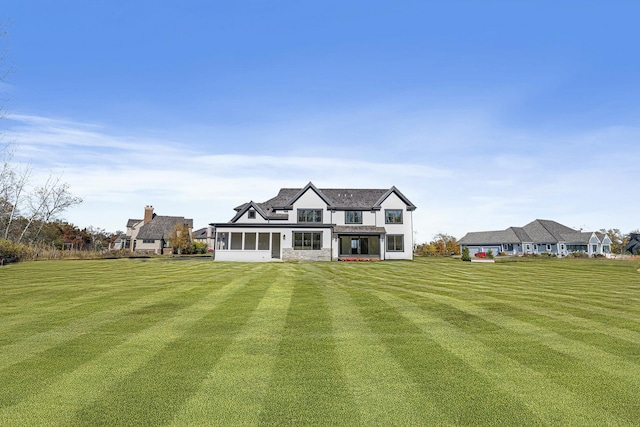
(211, 182, 416, 261)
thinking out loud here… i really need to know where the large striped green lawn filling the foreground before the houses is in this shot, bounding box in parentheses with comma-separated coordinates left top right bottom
(0, 259, 640, 426)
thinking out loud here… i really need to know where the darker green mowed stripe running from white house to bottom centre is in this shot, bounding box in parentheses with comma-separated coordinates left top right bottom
(260, 264, 359, 425)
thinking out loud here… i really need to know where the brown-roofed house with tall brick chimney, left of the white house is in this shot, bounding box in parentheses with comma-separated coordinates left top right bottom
(127, 206, 193, 254)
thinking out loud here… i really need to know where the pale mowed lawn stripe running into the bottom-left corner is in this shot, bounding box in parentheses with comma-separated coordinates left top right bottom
(0, 262, 268, 425)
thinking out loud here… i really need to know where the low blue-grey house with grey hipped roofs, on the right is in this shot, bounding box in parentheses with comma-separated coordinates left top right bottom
(458, 219, 611, 256)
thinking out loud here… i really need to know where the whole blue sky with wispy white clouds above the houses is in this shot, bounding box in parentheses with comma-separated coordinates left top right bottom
(0, 0, 640, 241)
